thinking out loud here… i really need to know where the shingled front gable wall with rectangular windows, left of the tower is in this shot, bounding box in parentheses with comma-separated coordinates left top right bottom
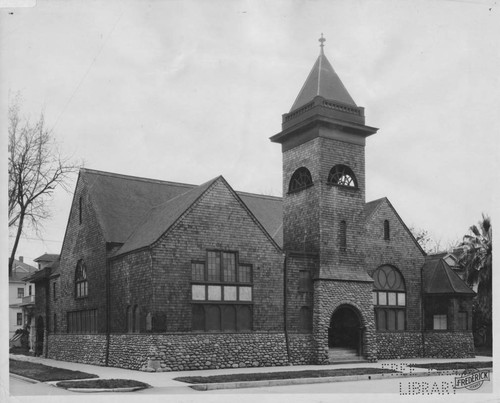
(147, 177, 283, 331)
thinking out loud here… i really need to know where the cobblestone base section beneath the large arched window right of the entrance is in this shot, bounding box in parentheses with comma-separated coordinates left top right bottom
(376, 332, 422, 360)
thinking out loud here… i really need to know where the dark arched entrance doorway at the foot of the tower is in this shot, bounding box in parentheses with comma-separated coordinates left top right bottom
(328, 305, 363, 361)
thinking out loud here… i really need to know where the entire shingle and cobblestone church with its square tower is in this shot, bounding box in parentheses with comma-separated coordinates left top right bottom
(29, 38, 474, 371)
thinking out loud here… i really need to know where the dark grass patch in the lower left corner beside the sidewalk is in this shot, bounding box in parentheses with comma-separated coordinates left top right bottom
(9, 359, 98, 382)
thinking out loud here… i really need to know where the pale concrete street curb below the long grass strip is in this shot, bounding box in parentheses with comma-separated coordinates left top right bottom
(188, 368, 493, 391)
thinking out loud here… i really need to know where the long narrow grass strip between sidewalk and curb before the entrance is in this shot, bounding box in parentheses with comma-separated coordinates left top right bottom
(174, 368, 398, 384)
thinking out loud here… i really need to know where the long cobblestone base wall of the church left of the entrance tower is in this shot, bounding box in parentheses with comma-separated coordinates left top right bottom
(48, 332, 314, 372)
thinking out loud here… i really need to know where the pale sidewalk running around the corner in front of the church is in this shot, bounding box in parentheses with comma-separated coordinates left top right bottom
(9, 354, 493, 388)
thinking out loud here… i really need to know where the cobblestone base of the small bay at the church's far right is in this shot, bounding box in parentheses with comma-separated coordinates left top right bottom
(424, 331, 475, 358)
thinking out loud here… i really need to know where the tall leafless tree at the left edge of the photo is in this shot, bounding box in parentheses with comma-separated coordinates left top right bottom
(8, 96, 78, 276)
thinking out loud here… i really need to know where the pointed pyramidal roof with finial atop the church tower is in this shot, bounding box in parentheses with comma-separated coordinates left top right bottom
(290, 34, 357, 112)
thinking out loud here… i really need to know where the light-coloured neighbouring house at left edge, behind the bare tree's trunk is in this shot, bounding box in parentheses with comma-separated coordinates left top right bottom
(9, 256, 36, 344)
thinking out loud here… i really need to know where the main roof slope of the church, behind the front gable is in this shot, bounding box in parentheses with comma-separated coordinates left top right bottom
(79, 168, 283, 253)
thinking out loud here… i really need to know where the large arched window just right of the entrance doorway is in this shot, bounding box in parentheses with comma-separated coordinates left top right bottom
(372, 265, 406, 331)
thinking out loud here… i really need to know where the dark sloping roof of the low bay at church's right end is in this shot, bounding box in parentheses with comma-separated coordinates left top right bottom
(422, 255, 475, 296)
